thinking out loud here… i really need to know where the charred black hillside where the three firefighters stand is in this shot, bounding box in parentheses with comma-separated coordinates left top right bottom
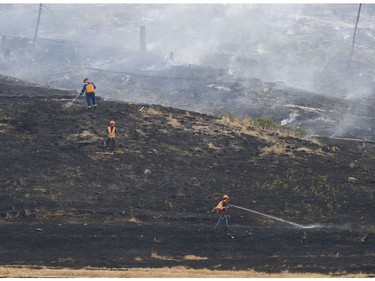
(0, 74, 375, 276)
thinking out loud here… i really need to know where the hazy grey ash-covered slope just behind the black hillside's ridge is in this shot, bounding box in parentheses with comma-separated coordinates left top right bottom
(47, 62, 375, 142)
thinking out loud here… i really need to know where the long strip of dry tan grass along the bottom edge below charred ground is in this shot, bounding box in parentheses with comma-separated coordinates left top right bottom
(0, 266, 368, 278)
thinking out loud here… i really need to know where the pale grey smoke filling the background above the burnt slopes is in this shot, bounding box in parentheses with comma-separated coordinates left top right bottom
(0, 4, 375, 140)
